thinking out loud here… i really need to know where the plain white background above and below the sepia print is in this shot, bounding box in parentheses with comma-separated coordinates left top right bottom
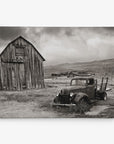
(0, 0, 114, 144)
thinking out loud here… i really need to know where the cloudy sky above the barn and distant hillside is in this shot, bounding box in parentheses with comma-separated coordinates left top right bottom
(0, 27, 114, 65)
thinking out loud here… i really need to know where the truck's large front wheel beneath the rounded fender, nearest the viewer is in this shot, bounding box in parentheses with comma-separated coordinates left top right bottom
(78, 97, 90, 113)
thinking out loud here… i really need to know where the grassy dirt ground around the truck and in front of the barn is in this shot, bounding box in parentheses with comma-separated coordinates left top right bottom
(0, 77, 114, 118)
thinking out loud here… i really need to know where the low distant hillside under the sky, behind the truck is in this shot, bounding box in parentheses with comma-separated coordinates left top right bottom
(45, 59, 114, 77)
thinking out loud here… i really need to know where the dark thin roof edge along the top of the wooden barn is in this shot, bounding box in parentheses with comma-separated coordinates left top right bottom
(0, 36, 45, 61)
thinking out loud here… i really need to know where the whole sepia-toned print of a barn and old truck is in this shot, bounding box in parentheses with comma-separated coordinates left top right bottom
(0, 26, 114, 118)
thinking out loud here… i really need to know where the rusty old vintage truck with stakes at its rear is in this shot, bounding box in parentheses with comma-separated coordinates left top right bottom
(53, 77, 108, 112)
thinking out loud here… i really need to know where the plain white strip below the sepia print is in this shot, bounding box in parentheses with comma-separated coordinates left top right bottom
(0, 119, 114, 144)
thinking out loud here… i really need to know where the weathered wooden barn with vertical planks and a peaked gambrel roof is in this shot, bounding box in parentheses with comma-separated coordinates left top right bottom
(0, 36, 45, 90)
